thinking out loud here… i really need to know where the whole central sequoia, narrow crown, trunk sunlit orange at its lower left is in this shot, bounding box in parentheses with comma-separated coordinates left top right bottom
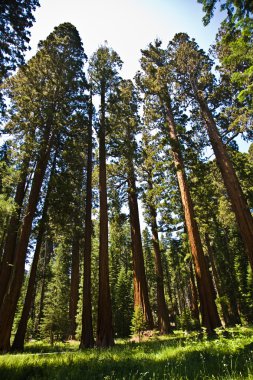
(107, 80, 153, 328)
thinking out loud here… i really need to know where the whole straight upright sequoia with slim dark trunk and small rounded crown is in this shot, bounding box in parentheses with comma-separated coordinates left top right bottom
(89, 45, 122, 347)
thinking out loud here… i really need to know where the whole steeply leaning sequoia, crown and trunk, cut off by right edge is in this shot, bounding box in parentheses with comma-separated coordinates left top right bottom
(169, 33, 253, 269)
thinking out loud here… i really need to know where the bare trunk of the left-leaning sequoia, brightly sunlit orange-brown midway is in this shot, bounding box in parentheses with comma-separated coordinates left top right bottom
(166, 100, 221, 332)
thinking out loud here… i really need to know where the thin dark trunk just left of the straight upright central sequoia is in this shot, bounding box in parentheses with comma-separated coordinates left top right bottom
(80, 91, 94, 348)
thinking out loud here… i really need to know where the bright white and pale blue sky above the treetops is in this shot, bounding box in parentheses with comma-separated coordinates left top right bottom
(27, 0, 224, 79)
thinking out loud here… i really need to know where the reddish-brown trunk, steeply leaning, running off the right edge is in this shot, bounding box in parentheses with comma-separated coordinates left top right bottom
(196, 93, 253, 271)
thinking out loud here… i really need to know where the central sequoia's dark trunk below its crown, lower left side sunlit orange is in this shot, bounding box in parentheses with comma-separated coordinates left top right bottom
(128, 160, 154, 329)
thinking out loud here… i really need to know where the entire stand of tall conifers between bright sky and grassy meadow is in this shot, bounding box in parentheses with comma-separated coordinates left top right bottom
(0, 0, 253, 353)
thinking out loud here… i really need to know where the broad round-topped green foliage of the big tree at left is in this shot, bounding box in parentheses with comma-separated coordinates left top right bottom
(2, 23, 86, 240)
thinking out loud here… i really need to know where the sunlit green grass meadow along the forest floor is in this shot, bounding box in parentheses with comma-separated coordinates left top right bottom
(0, 327, 253, 380)
